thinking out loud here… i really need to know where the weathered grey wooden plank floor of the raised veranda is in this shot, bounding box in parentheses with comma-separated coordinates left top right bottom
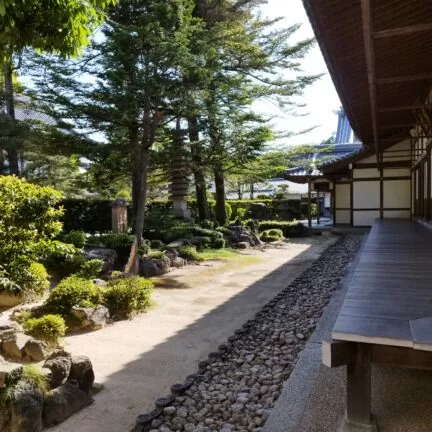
(333, 219, 432, 351)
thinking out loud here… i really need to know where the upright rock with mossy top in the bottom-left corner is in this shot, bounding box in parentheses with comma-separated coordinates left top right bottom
(11, 380, 44, 432)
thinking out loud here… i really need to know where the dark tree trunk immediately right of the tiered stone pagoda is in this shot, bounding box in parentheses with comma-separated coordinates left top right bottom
(188, 116, 210, 220)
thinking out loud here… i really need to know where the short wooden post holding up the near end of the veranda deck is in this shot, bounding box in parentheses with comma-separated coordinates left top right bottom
(346, 344, 372, 425)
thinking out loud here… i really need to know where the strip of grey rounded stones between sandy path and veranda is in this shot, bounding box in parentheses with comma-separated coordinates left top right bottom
(134, 234, 362, 432)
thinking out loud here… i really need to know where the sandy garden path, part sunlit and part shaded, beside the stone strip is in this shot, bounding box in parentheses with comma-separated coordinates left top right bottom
(52, 237, 336, 432)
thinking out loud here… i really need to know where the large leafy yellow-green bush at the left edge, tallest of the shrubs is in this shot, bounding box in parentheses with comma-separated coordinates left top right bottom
(0, 176, 63, 294)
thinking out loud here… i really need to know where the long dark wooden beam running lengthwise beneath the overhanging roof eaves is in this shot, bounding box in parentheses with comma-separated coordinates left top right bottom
(361, 0, 379, 161)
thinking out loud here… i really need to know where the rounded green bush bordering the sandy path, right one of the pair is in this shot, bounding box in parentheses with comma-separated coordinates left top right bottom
(103, 277, 153, 319)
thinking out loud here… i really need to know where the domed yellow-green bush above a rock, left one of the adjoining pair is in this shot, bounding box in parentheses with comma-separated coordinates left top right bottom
(45, 275, 101, 318)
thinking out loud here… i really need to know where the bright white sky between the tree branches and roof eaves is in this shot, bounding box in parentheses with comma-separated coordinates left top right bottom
(256, 0, 341, 145)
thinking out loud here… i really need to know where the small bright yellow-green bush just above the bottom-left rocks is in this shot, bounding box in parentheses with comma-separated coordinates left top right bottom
(23, 314, 66, 346)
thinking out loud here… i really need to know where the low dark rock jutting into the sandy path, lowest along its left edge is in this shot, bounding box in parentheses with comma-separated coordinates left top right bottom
(43, 383, 93, 427)
